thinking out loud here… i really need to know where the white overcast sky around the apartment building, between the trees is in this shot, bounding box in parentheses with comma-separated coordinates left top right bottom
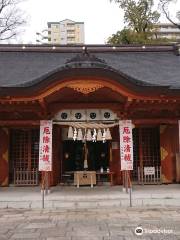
(17, 0, 180, 44)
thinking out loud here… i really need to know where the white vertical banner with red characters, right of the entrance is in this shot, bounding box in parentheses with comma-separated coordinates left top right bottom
(119, 120, 133, 170)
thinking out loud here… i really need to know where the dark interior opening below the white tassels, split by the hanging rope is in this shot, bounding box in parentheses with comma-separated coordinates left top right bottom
(62, 140, 109, 174)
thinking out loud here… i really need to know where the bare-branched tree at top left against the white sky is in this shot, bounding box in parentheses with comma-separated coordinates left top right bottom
(0, 0, 26, 40)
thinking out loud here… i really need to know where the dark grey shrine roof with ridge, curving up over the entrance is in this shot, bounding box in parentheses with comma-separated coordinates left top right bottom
(0, 45, 180, 93)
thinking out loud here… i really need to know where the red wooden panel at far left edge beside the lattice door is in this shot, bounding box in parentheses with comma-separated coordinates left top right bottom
(0, 128, 9, 186)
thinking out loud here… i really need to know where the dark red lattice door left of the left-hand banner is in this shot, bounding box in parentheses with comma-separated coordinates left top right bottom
(9, 129, 39, 185)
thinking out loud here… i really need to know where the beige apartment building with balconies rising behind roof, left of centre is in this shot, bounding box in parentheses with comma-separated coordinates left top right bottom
(48, 19, 84, 44)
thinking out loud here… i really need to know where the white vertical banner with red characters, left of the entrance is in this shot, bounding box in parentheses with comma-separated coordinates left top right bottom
(39, 120, 52, 171)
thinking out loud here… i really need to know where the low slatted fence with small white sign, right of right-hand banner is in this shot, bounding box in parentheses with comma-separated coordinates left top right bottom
(138, 166, 161, 184)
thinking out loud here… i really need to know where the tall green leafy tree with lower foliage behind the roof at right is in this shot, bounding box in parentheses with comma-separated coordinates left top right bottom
(108, 0, 178, 44)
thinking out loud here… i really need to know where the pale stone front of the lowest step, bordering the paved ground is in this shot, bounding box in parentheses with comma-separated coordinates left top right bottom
(0, 198, 180, 209)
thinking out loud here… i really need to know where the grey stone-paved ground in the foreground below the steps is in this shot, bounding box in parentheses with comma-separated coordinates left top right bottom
(0, 207, 180, 240)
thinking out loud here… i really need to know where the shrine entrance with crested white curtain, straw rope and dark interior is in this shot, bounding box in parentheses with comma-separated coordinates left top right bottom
(54, 109, 119, 184)
